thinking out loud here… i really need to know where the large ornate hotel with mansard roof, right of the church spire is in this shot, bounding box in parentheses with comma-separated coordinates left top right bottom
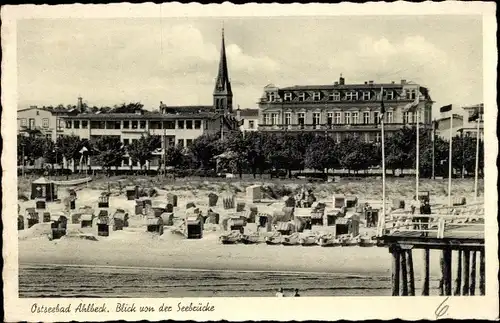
(258, 75, 433, 142)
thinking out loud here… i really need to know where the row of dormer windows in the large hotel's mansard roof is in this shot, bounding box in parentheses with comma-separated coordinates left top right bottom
(267, 89, 417, 102)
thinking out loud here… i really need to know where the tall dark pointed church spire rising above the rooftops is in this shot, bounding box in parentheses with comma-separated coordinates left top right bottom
(213, 25, 233, 113)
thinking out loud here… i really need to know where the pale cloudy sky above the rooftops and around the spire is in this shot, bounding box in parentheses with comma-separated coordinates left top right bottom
(17, 16, 483, 116)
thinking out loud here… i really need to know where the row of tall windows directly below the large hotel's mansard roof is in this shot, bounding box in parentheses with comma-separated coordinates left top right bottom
(263, 111, 394, 125)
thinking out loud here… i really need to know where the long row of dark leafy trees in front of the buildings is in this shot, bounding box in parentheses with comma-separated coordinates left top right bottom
(18, 127, 483, 177)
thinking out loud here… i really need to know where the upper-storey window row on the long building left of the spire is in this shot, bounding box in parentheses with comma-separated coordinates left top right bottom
(66, 120, 206, 129)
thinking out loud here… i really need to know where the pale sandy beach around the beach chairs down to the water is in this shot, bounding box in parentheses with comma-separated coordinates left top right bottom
(19, 178, 480, 295)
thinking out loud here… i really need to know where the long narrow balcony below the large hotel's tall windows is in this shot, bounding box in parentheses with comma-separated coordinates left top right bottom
(259, 123, 431, 131)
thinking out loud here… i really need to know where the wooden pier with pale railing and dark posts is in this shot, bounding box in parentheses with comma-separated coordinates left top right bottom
(377, 204, 485, 296)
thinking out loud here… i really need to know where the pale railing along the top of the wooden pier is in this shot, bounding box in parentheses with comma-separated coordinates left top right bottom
(377, 203, 484, 239)
